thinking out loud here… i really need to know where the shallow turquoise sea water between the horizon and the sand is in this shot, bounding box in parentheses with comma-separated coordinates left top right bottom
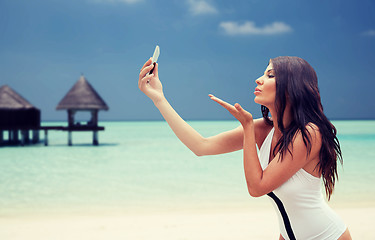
(0, 121, 375, 217)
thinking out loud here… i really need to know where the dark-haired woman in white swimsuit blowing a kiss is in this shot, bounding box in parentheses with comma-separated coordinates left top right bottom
(138, 57, 351, 240)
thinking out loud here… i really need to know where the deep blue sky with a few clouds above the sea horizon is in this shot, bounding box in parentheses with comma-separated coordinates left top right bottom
(0, 0, 375, 121)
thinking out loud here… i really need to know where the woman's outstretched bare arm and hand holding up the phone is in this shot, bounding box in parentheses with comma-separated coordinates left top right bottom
(138, 59, 243, 156)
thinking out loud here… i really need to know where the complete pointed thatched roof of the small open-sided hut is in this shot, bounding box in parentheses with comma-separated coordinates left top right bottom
(56, 76, 108, 110)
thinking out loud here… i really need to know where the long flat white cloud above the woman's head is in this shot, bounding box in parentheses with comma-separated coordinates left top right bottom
(219, 21, 293, 35)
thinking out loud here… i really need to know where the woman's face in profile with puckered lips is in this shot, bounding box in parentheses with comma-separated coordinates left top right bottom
(254, 61, 276, 108)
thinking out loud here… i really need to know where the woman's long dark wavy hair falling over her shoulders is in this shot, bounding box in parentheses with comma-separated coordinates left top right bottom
(261, 57, 343, 200)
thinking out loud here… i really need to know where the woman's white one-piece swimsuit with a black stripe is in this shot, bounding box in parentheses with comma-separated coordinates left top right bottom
(259, 128, 346, 240)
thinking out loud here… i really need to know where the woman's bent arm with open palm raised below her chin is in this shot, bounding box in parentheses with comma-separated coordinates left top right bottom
(211, 95, 321, 197)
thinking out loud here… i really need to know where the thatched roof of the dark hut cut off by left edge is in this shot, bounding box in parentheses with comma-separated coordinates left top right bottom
(0, 85, 37, 110)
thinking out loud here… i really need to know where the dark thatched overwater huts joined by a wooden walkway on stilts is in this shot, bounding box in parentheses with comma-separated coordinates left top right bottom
(0, 75, 109, 146)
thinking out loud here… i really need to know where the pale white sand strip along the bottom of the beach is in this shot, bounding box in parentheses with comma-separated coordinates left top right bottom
(0, 208, 375, 240)
